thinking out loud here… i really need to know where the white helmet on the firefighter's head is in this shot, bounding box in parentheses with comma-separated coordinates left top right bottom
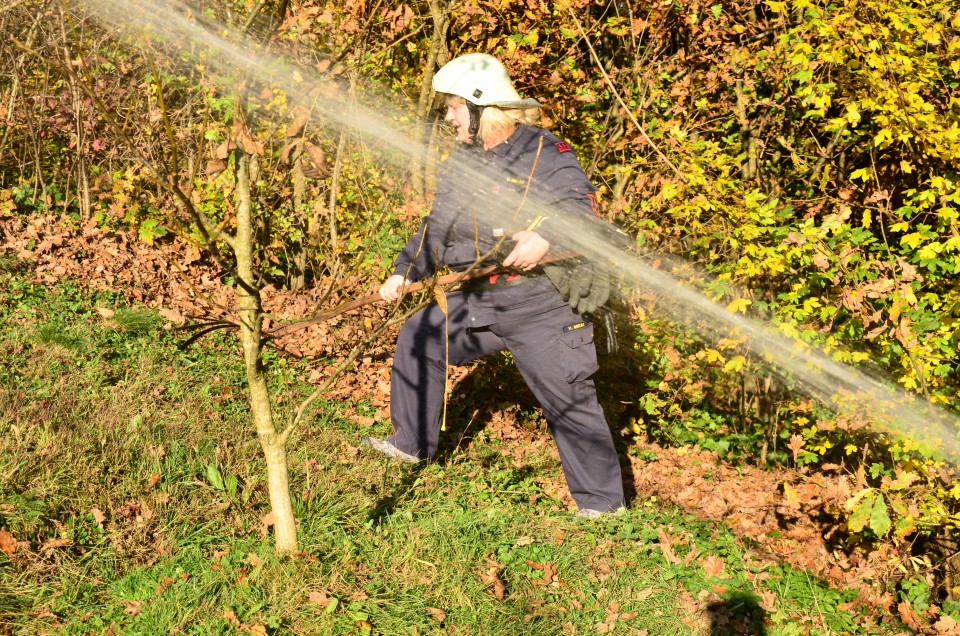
(433, 53, 540, 108)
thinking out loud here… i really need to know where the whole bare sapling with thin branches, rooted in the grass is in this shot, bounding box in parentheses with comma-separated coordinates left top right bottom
(39, 14, 459, 555)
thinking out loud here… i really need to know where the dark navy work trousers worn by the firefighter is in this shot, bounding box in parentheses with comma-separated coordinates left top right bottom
(389, 292, 624, 512)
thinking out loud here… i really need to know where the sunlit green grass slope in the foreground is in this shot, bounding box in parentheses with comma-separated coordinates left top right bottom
(0, 275, 899, 636)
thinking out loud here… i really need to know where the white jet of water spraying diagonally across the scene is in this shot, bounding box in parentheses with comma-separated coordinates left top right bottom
(84, 0, 960, 453)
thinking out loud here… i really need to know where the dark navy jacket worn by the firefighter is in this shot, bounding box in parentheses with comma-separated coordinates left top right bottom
(394, 125, 596, 326)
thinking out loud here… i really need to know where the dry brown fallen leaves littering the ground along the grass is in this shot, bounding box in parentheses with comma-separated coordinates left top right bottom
(0, 216, 924, 635)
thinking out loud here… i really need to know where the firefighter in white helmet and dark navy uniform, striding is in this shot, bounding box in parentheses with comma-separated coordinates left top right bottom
(363, 54, 624, 517)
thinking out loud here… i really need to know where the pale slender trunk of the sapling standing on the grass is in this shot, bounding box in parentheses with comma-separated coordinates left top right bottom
(236, 150, 298, 554)
